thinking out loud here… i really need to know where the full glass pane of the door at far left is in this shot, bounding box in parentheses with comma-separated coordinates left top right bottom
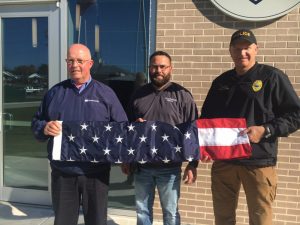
(2, 17, 48, 190)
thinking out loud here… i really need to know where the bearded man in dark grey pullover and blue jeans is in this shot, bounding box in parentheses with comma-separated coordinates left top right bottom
(122, 51, 198, 225)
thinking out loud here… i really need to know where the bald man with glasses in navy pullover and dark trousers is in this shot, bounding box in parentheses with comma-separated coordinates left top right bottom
(32, 44, 127, 225)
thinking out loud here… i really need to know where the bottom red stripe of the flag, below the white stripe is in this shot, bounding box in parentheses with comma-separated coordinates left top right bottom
(200, 144, 252, 160)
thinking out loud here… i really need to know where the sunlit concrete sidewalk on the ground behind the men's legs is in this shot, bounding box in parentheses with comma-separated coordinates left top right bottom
(0, 201, 138, 225)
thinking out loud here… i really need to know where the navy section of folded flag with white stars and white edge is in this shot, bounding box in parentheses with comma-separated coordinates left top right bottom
(52, 119, 250, 164)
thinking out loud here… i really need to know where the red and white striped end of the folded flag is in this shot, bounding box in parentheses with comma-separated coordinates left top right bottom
(196, 118, 252, 160)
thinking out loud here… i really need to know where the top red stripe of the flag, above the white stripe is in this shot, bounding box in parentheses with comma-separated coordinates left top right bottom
(196, 118, 247, 128)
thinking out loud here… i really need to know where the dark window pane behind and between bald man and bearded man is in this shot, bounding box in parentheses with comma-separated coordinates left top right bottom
(69, 0, 150, 108)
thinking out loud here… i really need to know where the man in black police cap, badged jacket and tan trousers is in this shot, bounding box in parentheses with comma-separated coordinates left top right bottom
(201, 29, 300, 225)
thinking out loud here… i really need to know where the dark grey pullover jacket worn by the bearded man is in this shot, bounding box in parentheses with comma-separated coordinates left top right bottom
(129, 82, 198, 168)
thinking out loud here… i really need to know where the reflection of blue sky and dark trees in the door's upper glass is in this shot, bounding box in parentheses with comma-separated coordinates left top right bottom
(3, 18, 48, 103)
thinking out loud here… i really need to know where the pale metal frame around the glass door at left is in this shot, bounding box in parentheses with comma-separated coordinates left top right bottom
(0, 1, 62, 205)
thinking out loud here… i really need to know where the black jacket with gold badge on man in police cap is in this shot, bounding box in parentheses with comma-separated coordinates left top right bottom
(201, 63, 300, 166)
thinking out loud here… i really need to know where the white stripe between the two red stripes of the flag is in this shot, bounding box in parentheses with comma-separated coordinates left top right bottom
(198, 128, 249, 146)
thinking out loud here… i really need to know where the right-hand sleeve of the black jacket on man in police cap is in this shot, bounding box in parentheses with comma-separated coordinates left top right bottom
(267, 71, 300, 137)
